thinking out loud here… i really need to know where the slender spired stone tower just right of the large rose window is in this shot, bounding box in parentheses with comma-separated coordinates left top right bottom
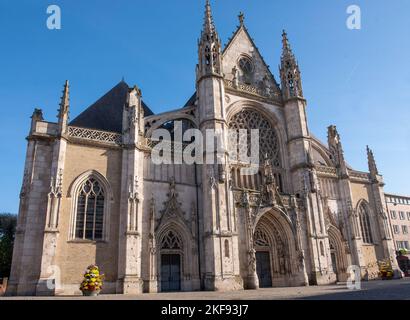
(280, 31, 334, 284)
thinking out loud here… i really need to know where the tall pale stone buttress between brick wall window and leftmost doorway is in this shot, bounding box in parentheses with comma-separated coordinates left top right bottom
(117, 87, 144, 294)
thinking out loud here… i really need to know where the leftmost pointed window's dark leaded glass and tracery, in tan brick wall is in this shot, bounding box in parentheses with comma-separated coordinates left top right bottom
(74, 176, 106, 241)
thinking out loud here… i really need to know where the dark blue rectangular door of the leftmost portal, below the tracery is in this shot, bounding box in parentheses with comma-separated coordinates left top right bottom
(161, 254, 181, 292)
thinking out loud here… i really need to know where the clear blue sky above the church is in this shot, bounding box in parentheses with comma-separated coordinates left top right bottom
(0, 0, 410, 213)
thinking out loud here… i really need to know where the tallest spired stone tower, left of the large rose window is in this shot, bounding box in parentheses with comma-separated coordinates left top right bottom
(196, 1, 241, 290)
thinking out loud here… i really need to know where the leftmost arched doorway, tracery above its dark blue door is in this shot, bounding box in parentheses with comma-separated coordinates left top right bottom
(160, 230, 183, 292)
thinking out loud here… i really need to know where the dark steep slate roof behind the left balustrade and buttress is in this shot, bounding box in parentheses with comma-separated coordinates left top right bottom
(70, 81, 154, 133)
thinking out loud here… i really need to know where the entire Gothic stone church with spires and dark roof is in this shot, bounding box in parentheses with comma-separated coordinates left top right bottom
(7, 1, 399, 295)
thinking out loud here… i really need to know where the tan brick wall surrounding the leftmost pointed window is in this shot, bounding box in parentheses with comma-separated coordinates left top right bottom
(56, 144, 121, 291)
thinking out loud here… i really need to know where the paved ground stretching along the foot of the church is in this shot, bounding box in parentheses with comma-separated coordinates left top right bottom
(0, 278, 410, 300)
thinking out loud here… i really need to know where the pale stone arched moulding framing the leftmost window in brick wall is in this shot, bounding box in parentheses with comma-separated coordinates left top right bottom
(67, 170, 113, 241)
